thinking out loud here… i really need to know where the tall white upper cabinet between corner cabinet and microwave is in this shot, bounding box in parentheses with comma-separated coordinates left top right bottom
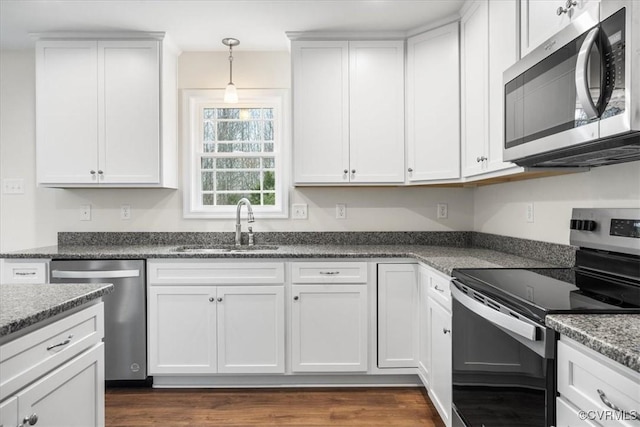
(461, 0, 522, 178)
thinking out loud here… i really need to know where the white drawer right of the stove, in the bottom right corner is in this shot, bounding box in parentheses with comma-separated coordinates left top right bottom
(558, 336, 640, 426)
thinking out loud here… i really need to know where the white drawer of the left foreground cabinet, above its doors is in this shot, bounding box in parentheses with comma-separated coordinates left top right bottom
(0, 303, 104, 400)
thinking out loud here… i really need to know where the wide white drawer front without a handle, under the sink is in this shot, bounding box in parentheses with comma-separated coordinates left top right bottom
(147, 260, 284, 285)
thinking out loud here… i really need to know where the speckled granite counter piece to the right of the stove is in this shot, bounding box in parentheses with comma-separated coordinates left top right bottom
(546, 314, 640, 372)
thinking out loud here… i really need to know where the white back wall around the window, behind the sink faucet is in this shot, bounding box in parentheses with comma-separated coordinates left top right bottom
(0, 50, 473, 251)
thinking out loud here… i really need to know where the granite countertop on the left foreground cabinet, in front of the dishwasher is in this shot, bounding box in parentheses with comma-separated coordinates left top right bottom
(0, 283, 113, 338)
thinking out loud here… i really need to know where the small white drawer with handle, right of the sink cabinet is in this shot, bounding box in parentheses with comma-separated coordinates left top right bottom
(291, 262, 367, 283)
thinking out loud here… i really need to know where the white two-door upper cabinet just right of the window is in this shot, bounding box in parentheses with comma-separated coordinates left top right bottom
(292, 41, 404, 184)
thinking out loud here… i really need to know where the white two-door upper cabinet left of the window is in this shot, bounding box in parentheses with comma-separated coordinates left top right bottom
(36, 35, 177, 187)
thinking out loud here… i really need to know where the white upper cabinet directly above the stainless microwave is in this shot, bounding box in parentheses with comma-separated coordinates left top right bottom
(520, 0, 600, 56)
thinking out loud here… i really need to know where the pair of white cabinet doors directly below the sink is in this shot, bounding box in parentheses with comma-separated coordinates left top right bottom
(149, 285, 284, 375)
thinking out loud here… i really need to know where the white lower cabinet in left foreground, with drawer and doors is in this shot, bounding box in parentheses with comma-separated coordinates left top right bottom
(0, 304, 104, 427)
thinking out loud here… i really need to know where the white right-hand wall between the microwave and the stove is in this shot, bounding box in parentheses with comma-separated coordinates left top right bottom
(473, 162, 640, 244)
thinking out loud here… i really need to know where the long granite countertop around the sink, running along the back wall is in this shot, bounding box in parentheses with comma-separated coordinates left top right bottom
(0, 245, 562, 275)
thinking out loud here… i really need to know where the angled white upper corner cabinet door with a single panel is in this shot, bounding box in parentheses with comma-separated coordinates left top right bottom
(407, 22, 460, 182)
